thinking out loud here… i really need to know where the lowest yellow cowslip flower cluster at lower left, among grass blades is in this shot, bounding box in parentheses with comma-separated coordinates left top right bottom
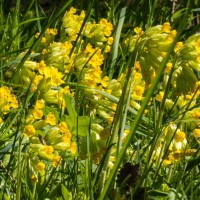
(22, 99, 76, 181)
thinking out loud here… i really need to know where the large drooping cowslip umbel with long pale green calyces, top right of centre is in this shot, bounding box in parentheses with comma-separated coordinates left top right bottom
(124, 22, 176, 88)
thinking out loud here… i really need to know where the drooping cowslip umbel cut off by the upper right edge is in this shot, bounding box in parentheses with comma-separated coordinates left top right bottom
(173, 34, 200, 95)
